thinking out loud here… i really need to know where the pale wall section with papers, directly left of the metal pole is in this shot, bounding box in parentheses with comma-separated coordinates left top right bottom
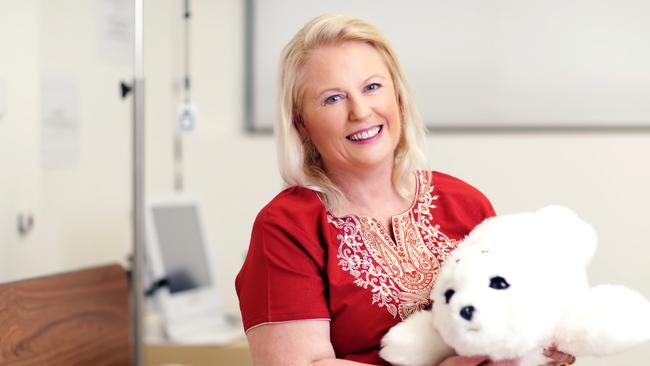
(37, 0, 133, 276)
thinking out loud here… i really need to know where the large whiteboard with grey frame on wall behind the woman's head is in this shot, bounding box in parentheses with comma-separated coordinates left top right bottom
(246, 0, 650, 131)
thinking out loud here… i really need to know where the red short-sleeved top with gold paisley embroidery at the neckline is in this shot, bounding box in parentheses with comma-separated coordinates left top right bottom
(235, 172, 494, 364)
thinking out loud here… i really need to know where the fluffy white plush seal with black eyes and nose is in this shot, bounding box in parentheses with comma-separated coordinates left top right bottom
(380, 206, 650, 366)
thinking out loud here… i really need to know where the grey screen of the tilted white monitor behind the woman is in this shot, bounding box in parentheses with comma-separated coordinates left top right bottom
(152, 205, 211, 293)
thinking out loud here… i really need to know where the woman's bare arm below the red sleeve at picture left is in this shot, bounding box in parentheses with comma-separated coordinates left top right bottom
(246, 320, 372, 366)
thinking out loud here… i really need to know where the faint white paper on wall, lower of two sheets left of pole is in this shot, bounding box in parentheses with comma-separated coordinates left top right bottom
(41, 75, 80, 169)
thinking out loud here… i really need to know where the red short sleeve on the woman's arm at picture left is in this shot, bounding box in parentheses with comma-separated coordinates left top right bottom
(235, 189, 330, 331)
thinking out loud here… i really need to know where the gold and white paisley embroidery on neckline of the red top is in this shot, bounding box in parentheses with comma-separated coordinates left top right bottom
(327, 173, 458, 319)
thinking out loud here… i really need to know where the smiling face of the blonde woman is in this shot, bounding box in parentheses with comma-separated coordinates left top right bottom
(298, 42, 401, 174)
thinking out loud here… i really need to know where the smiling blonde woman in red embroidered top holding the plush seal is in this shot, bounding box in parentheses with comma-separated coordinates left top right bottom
(236, 16, 568, 366)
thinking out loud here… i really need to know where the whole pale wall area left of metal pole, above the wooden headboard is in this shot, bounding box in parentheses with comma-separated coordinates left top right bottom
(0, 0, 132, 281)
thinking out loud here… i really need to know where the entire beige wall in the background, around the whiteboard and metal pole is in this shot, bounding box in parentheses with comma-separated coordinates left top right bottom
(0, 0, 650, 365)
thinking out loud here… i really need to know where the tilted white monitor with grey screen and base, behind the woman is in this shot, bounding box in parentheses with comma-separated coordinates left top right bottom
(145, 196, 237, 343)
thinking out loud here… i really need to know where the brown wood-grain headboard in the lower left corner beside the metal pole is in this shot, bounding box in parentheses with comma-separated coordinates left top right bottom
(0, 265, 132, 366)
